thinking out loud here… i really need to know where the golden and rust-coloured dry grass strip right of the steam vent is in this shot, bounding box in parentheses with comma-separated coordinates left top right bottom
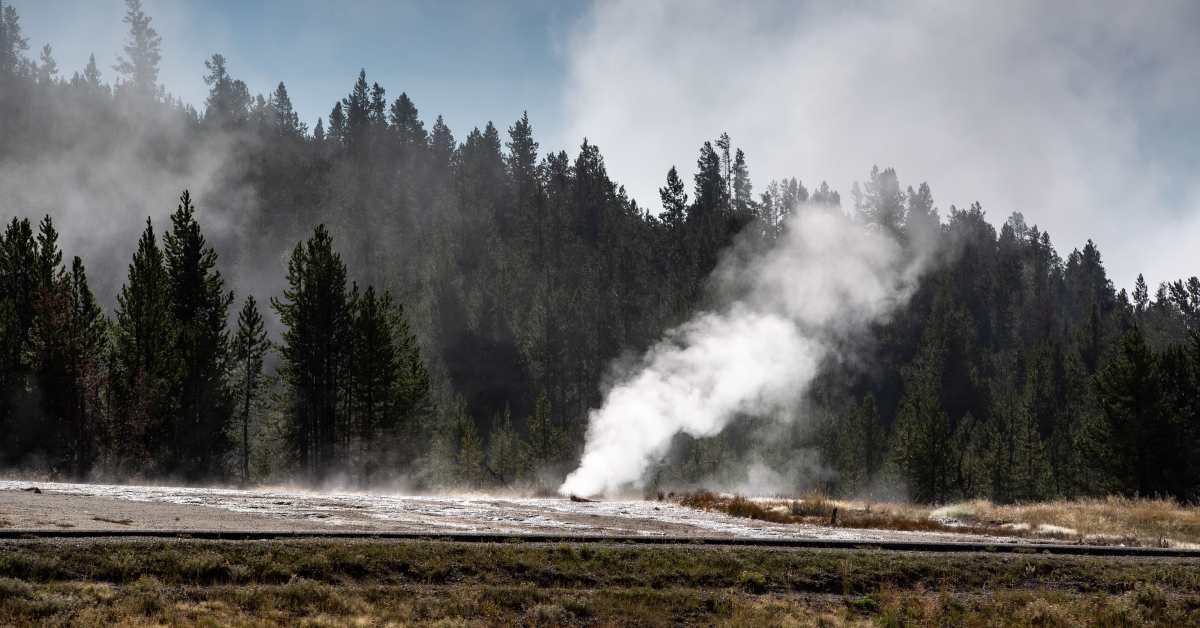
(678, 491, 1200, 548)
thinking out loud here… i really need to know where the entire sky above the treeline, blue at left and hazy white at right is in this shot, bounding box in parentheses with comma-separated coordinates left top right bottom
(11, 0, 1200, 287)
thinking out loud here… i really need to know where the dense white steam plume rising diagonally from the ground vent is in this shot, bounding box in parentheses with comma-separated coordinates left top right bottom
(559, 208, 925, 495)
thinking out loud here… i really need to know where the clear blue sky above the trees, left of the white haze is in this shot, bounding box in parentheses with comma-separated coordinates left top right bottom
(8, 0, 586, 148)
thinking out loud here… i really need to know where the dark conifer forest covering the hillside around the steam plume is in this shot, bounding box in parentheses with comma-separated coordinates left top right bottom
(0, 0, 1200, 502)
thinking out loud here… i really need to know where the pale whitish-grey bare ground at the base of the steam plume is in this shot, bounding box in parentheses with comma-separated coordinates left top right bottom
(0, 480, 1016, 543)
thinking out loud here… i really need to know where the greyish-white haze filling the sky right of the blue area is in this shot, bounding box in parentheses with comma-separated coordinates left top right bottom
(564, 0, 1200, 288)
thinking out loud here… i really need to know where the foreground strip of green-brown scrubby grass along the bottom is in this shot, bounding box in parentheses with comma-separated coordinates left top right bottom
(0, 540, 1200, 626)
